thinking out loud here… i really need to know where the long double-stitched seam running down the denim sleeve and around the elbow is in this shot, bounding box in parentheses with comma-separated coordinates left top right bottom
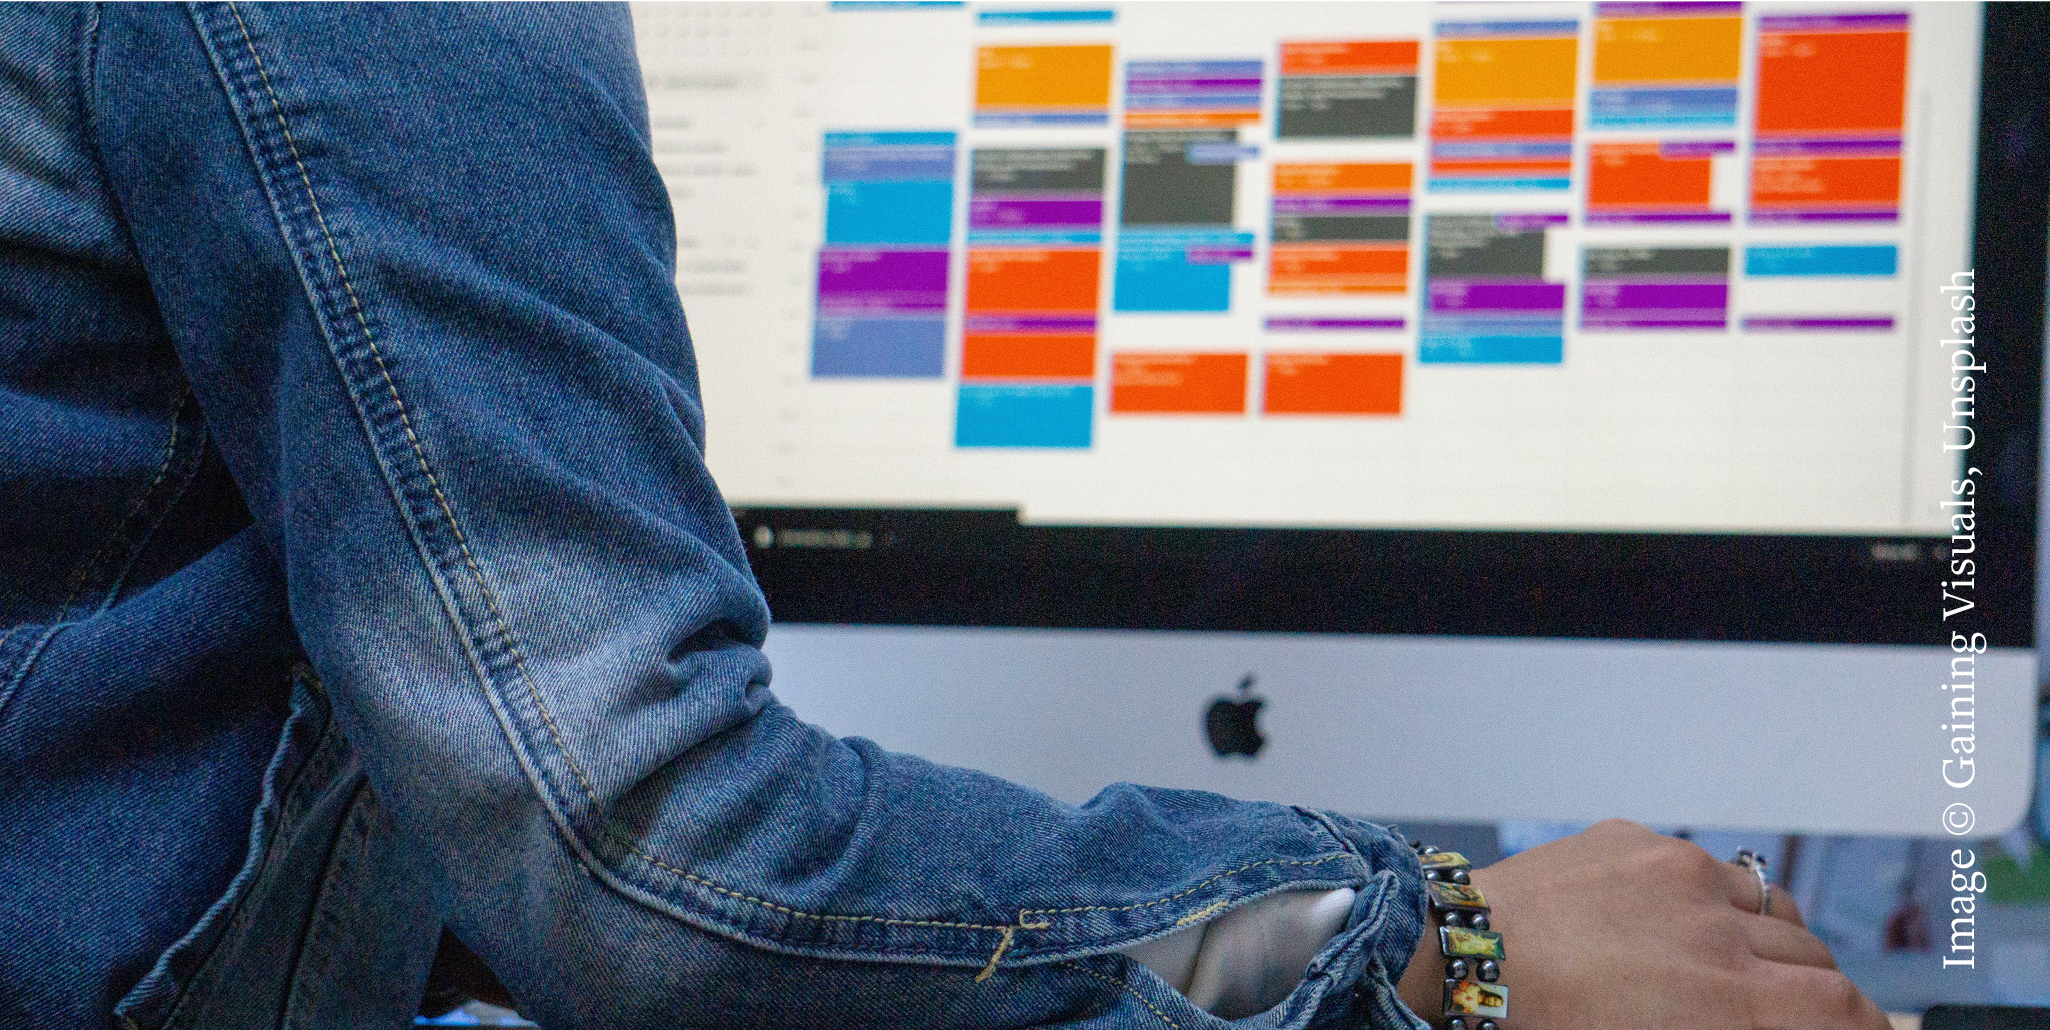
(199, 2, 1019, 947)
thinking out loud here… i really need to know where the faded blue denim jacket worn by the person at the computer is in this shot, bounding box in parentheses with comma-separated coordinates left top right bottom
(0, 4, 1423, 1030)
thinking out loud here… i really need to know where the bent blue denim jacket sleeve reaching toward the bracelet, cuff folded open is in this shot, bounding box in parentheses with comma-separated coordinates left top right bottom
(88, 4, 1423, 1028)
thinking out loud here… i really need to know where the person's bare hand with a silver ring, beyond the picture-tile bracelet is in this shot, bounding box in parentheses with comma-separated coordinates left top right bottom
(1400, 819, 1888, 1030)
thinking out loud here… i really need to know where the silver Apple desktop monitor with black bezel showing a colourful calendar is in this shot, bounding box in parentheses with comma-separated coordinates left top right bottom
(633, 2, 2046, 837)
